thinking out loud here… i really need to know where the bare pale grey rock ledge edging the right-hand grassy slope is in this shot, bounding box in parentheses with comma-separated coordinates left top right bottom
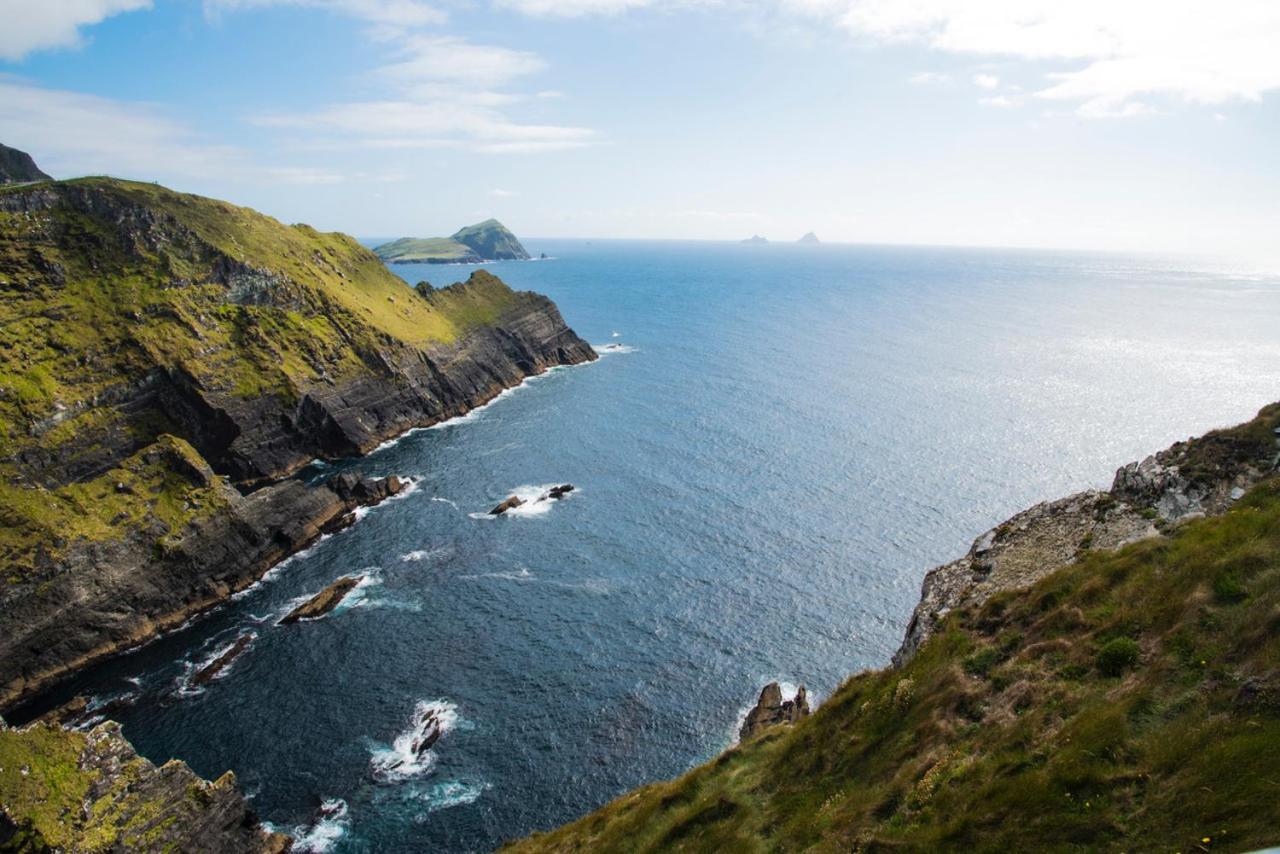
(893, 403, 1280, 667)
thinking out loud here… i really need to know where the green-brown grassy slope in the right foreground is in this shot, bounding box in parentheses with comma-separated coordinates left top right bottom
(517, 481, 1280, 851)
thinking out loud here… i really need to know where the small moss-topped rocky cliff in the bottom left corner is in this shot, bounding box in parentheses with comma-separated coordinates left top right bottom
(0, 721, 289, 854)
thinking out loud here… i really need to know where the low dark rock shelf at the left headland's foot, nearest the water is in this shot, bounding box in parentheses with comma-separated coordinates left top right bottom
(0, 469, 404, 705)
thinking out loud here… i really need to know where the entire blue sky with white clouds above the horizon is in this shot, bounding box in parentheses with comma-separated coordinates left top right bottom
(0, 0, 1280, 262)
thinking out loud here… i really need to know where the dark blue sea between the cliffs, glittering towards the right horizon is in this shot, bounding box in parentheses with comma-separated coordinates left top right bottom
(20, 241, 1280, 851)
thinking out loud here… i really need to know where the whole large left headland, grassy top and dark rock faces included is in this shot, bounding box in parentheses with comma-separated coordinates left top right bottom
(0, 178, 595, 708)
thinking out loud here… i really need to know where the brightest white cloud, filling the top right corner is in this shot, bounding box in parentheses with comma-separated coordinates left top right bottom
(778, 0, 1280, 117)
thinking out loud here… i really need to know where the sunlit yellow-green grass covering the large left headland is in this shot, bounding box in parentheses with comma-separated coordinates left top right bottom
(0, 178, 515, 577)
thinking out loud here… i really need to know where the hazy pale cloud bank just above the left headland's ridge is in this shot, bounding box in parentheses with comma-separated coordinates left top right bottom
(0, 76, 343, 184)
